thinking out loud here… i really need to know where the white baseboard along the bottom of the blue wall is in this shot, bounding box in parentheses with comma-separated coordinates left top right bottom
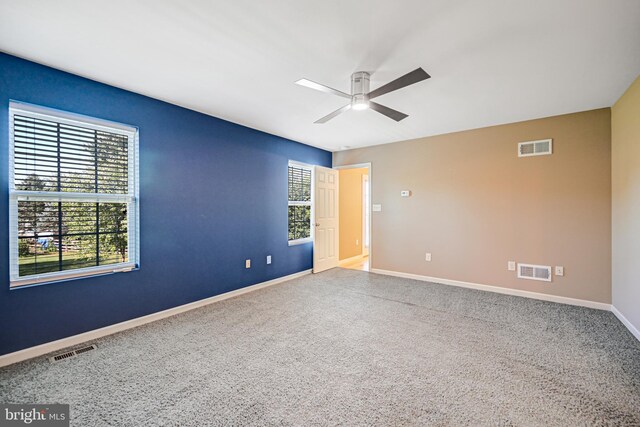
(0, 270, 311, 367)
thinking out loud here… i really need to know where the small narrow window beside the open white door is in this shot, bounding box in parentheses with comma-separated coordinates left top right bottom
(289, 162, 312, 244)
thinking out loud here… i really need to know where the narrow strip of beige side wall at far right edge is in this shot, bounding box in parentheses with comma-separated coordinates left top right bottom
(611, 77, 640, 330)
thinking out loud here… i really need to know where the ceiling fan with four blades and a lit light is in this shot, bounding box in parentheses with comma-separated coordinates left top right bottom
(296, 68, 431, 123)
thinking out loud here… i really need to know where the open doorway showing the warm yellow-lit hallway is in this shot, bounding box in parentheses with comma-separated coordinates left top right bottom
(337, 164, 371, 271)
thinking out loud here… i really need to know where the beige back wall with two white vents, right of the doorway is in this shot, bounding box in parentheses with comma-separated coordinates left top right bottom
(334, 108, 611, 303)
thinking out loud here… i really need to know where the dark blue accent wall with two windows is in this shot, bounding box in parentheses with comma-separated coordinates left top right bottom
(0, 53, 331, 354)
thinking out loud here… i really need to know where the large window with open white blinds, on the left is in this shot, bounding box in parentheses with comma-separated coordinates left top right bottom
(9, 102, 139, 287)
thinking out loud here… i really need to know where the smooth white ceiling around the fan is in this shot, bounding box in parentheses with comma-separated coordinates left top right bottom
(0, 0, 640, 151)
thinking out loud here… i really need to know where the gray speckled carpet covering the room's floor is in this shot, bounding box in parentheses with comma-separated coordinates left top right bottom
(0, 269, 640, 426)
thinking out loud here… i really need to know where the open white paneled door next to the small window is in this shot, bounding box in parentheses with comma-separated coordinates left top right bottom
(313, 166, 340, 273)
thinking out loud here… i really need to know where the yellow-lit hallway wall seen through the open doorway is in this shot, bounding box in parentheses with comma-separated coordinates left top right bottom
(340, 168, 368, 260)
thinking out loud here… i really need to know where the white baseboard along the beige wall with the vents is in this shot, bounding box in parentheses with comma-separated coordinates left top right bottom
(371, 268, 611, 311)
